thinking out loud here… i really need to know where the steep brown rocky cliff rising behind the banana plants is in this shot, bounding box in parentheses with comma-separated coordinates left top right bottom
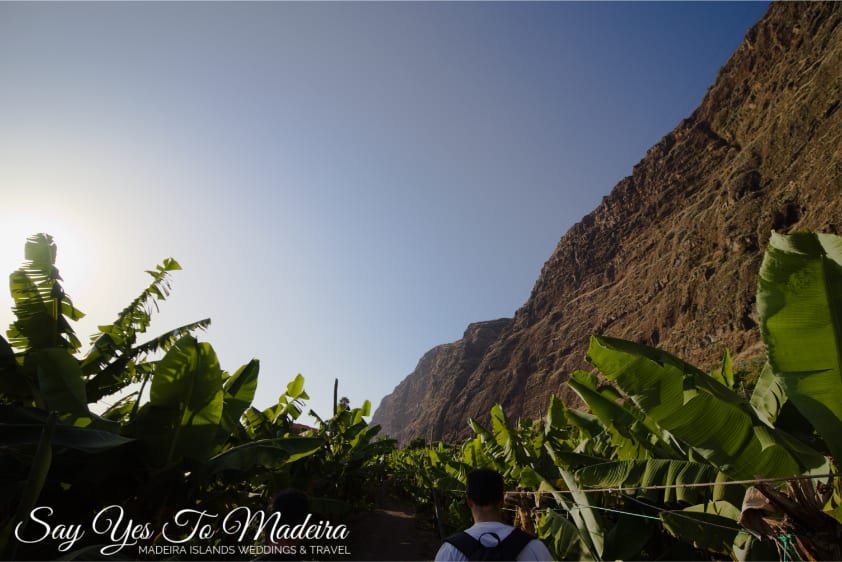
(374, 3, 842, 441)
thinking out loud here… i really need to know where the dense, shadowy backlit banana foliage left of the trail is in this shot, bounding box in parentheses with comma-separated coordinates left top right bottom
(0, 234, 394, 559)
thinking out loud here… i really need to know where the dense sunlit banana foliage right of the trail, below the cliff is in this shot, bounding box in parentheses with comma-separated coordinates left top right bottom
(392, 233, 842, 560)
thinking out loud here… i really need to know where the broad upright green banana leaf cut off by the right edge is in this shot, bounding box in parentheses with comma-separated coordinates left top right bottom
(757, 233, 842, 459)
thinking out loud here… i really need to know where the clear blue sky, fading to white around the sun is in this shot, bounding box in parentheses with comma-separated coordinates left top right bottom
(0, 2, 768, 422)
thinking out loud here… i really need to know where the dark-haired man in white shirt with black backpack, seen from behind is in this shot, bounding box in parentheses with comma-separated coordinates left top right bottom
(436, 468, 553, 561)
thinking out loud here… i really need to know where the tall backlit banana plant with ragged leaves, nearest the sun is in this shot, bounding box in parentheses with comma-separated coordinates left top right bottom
(0, 233, 210, 420)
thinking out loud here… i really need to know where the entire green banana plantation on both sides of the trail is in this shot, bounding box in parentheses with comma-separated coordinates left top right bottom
(0, 233, 842, 561)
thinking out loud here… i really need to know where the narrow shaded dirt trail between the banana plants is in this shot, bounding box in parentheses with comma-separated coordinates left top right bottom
(348, 482, 440, 560)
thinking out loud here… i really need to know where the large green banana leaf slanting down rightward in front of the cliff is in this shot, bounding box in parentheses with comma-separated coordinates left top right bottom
(588, 336, 827, 479)
